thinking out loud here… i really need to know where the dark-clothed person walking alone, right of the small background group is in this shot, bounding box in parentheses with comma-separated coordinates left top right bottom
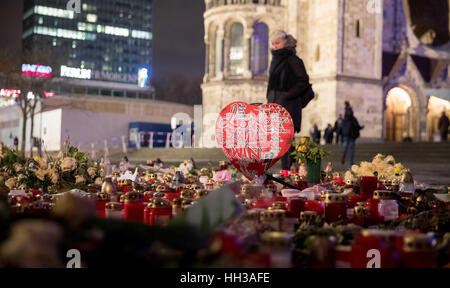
(341, 102, 364, 165)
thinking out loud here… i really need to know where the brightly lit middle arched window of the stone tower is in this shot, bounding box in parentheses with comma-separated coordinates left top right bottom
(228, 22, 245, 76)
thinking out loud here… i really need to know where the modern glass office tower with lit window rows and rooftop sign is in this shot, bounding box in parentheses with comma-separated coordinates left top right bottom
(23, 0, 152, 88)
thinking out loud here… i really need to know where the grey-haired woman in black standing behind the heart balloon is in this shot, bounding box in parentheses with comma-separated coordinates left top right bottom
(267, 31, 314, 170)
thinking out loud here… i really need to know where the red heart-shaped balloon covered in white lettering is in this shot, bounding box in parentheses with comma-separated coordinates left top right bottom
(216, 102, 294, 180)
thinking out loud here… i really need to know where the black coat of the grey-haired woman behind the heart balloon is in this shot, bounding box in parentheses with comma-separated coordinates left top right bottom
(267, 48, 314, 132)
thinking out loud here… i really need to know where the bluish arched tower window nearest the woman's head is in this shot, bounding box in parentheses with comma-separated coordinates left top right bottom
(251, 22, 269, 75)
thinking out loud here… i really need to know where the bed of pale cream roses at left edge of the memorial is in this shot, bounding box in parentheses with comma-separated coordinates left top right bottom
(0, 143, 102, 193)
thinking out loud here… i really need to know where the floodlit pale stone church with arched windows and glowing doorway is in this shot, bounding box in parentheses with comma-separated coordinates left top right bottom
(202, 0, 450, 147)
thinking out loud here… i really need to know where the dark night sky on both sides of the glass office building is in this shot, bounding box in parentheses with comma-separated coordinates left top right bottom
(0, 0, 205, 84)
